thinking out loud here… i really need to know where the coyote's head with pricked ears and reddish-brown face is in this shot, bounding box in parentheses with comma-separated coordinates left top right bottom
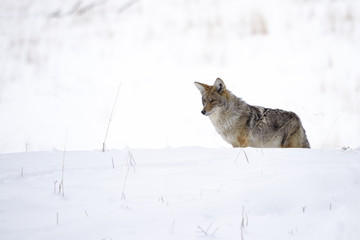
(195, 78, 227, 116)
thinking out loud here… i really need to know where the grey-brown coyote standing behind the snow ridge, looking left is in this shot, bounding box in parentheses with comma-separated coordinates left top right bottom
(195, 78, 310, 148)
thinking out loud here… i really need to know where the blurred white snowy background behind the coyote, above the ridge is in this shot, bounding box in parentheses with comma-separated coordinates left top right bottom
(0, 0, 360, 152)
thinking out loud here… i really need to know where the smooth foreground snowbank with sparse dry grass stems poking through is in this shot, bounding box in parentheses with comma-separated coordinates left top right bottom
(0, 147, 360, 240)
